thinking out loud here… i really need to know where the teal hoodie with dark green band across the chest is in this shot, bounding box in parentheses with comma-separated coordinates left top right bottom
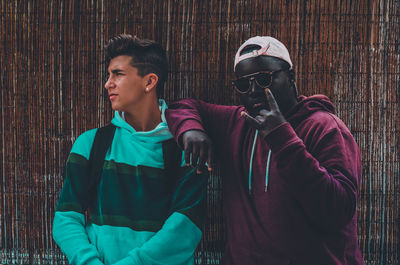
(53, 100, 207, 265)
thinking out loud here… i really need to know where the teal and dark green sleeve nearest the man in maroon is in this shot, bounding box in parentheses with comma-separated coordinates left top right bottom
(111, 167, 207, 265)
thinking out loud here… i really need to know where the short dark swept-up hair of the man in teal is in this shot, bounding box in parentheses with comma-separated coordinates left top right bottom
(105, 34, 168, 98)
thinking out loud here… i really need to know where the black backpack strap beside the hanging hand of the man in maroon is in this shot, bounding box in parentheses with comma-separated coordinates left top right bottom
(162, 138, 182, 180)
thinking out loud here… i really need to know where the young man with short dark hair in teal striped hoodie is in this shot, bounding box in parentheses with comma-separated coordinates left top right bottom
(53, 35, 207, 265)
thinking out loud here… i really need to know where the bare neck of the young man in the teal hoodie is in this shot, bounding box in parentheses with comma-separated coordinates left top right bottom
(125, 98, 161, 132)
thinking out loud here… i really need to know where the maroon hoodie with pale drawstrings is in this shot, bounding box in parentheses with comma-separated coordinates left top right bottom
(166, 95, 363, 265)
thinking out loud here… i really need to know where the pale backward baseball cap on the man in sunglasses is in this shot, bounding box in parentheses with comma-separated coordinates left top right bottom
(233, 36, 293, 70)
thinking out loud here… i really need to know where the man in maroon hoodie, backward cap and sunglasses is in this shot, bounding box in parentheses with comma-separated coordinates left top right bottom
(166, 37, 363, 265)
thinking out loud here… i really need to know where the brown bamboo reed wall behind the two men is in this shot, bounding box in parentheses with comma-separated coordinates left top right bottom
(0, 0, 400, 265)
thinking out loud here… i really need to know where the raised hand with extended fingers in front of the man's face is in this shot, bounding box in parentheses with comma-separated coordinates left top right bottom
(241, 88, 286, 137)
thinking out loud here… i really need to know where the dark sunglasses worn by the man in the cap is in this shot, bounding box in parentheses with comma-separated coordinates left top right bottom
(232, 69, 289, 94)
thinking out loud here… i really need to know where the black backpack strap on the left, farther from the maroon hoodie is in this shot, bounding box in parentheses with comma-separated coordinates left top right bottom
(88, 123, 116, 206)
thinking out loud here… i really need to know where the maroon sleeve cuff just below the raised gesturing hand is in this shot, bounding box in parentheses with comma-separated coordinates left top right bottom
(264, 122, 301, 152)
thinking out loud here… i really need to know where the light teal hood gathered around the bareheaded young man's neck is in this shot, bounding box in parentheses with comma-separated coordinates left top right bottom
(111, 99, 172, 144)
